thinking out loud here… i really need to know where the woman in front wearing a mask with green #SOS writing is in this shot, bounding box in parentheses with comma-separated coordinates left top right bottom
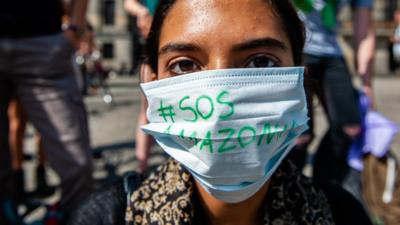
(69, 0, 333, 225)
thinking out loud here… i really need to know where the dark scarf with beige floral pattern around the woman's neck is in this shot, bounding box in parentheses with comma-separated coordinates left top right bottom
(126, 159, 334, 225)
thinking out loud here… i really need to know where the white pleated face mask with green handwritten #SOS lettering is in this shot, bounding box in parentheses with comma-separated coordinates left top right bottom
(141, 67, 308, 203)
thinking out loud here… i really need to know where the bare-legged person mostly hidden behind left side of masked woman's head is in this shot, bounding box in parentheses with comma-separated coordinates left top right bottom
(125, 0, 158, 173)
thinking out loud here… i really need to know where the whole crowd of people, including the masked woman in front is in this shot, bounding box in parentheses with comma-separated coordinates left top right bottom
(0, 0, 400, 225)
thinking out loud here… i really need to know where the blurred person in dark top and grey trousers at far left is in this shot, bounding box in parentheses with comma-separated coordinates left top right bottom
(0, 0, 92, 220)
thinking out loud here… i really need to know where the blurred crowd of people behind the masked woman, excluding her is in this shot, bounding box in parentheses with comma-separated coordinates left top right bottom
(0, 0, 400, 225)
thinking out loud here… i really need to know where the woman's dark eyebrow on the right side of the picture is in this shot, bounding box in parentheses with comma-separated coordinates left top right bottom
(233, 38, 288, 51)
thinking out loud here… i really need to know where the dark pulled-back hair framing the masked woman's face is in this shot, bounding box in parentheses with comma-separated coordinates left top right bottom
(146, 0, 305, 72)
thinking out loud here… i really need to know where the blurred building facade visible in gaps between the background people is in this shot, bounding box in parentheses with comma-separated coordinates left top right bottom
(88, 0, 400, 74)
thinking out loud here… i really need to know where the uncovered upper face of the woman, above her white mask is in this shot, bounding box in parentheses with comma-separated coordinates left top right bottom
(158, 0, 294, 79)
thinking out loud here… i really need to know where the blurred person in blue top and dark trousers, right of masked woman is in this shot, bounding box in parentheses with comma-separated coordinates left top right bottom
(293, 0, 375, 199)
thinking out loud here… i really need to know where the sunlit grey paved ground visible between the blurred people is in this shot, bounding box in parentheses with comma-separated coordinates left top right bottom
(20, 73, 400, 221)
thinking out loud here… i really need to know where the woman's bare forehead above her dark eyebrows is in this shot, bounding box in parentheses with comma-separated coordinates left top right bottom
(160, 0, 289, 50)
